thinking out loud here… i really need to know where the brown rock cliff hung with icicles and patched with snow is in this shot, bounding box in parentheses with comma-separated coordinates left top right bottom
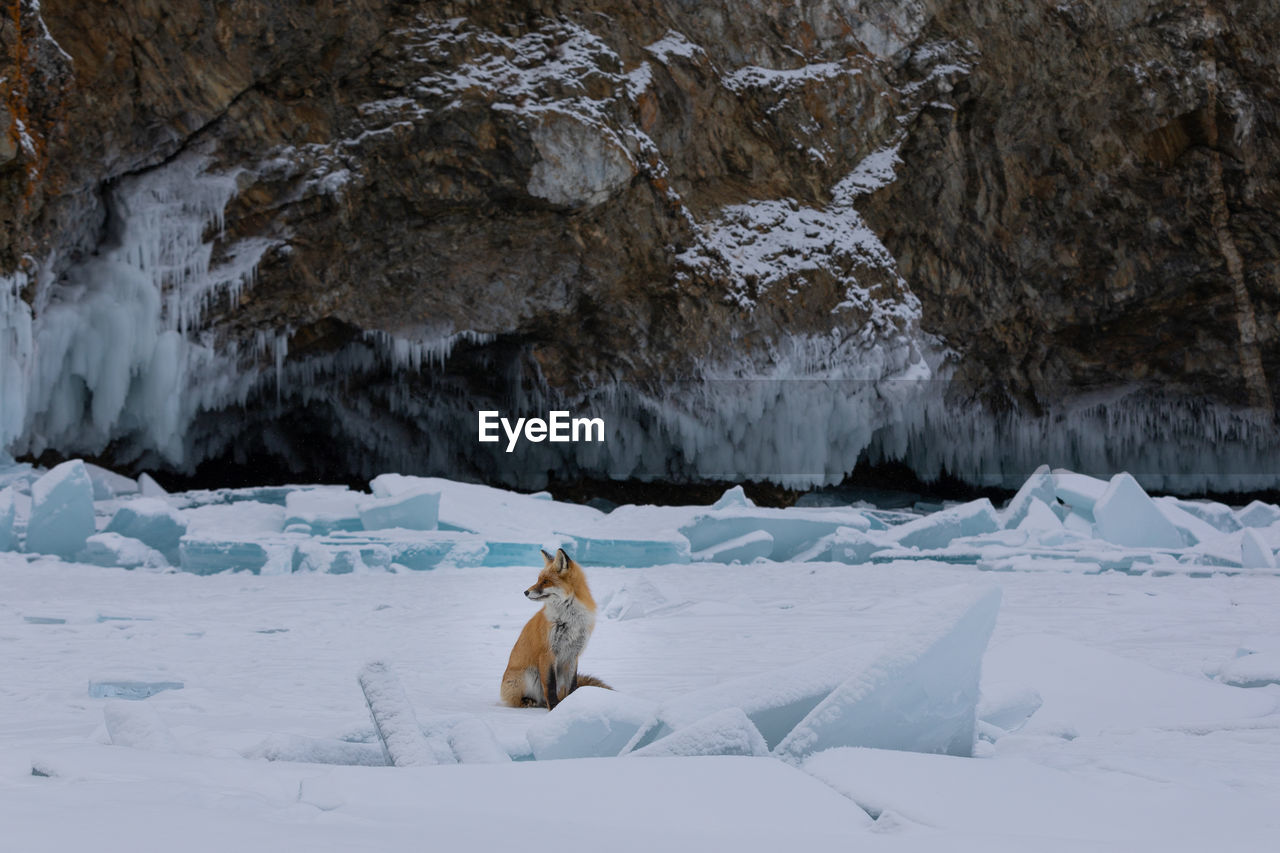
(0, 0, 1280, 488)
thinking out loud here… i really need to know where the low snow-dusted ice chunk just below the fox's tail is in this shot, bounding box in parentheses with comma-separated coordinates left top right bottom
(527, 686, 658, 761)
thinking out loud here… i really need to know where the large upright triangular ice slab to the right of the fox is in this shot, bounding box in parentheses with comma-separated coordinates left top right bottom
(773, 588, 1000, 763)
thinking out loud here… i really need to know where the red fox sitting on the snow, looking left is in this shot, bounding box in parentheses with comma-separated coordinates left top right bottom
(502, 548, 612, 710)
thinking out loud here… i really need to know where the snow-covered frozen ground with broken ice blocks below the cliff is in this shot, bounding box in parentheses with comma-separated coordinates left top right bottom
(0, 469, 1280, 853)
